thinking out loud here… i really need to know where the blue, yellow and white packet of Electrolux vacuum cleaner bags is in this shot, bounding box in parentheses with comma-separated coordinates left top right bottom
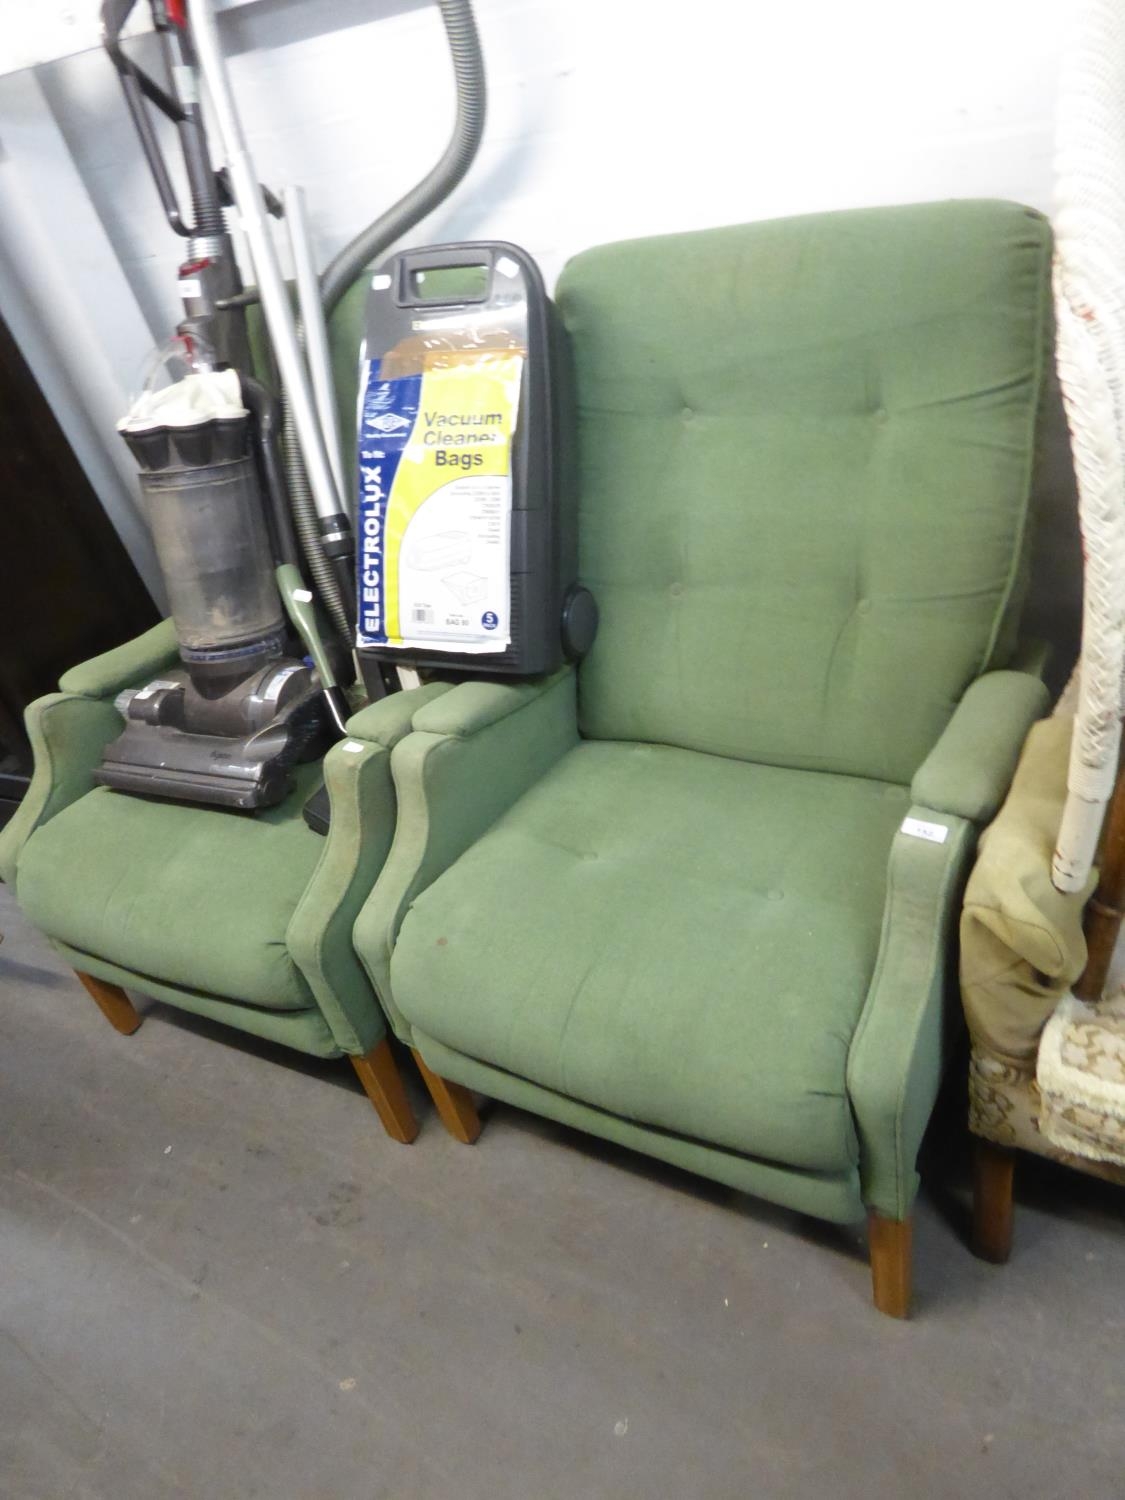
(357, 350, 524, 653)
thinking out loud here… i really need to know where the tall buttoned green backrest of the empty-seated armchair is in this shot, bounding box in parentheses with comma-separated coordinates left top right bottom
(558, 201, 1050, 782)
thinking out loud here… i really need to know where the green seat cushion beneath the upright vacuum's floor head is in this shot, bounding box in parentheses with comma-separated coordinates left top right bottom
(17, 764, 324, 1011)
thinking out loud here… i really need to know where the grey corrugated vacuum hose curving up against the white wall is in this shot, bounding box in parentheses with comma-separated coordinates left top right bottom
(282, 0, 486, 645)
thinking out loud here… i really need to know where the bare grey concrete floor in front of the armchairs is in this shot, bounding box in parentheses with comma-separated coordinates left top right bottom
(0, 887, 1125, 1500)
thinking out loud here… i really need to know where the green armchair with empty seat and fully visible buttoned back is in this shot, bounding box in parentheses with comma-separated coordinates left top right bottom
(354, 203, 1050, 1316)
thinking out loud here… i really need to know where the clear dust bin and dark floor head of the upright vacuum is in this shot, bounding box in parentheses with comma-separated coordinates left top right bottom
(95, 380, 324, 810)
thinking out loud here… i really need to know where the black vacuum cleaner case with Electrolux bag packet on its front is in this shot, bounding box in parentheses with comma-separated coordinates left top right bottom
(357, 242, 597, 692)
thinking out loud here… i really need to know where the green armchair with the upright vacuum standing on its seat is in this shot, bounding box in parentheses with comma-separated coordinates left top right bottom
(0, 621, 446, 1142)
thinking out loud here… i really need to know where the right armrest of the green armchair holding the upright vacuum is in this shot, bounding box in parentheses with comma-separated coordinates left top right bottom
(285, 683, 452, 1055)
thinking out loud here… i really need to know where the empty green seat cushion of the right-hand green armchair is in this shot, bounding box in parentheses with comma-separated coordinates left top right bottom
(392, 741, 908, 1170)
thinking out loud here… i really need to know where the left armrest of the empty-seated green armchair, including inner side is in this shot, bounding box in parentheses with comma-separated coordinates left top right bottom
(354, 668, 578, 1034)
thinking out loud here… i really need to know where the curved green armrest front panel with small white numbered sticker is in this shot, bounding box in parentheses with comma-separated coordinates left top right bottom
(848, 806, 977, 1220)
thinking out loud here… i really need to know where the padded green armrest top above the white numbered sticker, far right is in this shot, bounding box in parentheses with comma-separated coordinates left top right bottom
(911, 672, 1049, 824)
